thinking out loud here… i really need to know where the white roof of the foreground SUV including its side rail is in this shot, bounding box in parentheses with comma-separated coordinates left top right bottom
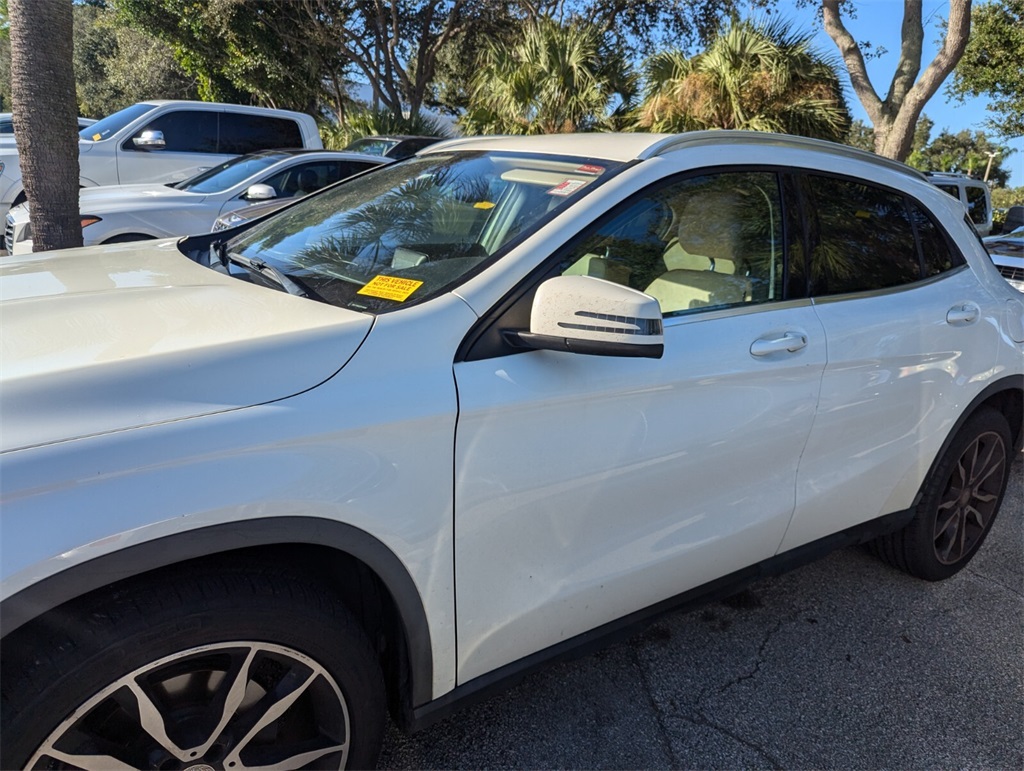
(420, 129, 925, 179)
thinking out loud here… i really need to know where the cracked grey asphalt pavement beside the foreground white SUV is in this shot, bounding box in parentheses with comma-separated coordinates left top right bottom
(380, 458, 1024, 770)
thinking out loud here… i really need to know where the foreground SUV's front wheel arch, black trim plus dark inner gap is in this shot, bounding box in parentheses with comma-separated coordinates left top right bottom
(0, 517, 433, 723)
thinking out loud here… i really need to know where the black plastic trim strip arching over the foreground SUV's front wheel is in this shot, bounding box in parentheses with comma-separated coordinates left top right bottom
(0, 517, 433, 708)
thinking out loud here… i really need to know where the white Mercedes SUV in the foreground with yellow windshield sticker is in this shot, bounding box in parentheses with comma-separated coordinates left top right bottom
(0, 131, 1024, 770)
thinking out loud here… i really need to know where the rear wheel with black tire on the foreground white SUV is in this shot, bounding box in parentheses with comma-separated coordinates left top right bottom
(869, 408, 1013, 581)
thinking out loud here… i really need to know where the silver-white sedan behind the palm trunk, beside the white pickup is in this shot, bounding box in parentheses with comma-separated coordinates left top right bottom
(4, 149, 389, 254)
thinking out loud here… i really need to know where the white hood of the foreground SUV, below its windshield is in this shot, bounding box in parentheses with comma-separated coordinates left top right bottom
(0, 241, 373, 452)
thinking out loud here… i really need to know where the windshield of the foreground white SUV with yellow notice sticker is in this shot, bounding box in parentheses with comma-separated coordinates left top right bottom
(222, 152, 621, 312)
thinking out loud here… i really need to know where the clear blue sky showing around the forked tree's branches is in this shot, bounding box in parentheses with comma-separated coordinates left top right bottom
(777, 0, 1024, 186)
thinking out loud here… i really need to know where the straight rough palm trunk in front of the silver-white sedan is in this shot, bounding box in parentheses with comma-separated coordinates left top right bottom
(8, 0, 82, 252)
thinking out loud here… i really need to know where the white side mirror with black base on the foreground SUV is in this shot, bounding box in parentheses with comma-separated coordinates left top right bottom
(505, 275, 665, 358)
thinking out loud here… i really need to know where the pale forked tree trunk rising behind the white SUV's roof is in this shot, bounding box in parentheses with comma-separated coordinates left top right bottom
(821, 0, 971, 161)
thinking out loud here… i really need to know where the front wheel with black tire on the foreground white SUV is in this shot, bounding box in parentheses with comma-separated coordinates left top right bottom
(0, 567, 386, 771)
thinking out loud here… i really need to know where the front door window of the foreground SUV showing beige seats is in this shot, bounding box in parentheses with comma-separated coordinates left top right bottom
(562, 172, 785, 315)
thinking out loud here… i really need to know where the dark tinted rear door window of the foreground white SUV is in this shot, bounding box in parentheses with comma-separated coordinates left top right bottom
(806, 175, 923, 297)
